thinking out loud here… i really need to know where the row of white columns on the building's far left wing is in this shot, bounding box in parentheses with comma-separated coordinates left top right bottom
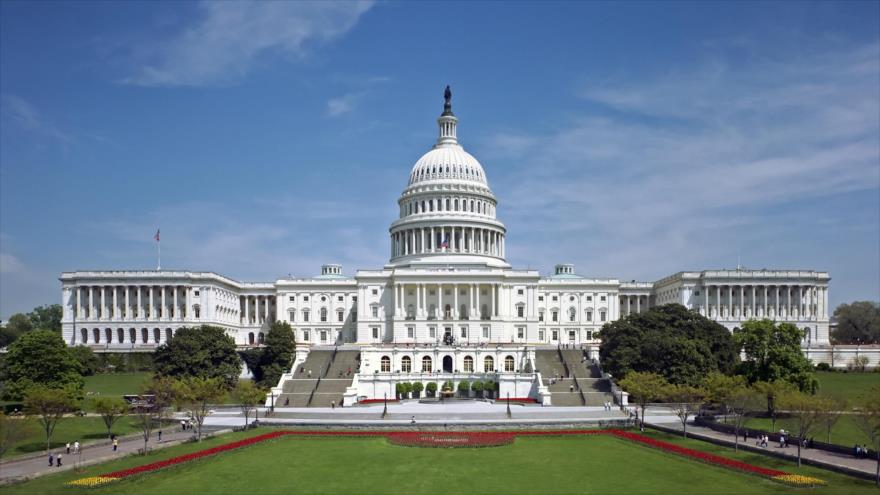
(75, 285, 192, 321)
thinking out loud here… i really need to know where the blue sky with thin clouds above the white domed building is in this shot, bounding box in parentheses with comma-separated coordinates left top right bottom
(0, 1, 880, 319)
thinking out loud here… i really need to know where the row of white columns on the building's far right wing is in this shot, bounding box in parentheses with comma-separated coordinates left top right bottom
(700, 284, 828, 320)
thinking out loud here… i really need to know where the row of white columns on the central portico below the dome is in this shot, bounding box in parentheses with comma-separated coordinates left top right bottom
(394, 283, 500, 320)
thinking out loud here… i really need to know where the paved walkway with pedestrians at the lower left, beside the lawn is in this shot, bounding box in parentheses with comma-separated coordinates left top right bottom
(0, 426, 227, 486)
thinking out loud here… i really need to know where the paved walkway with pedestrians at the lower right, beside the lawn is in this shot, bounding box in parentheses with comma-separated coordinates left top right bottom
(646, 415, 877, 479)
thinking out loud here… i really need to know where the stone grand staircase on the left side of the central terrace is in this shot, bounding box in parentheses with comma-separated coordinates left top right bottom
(275, 349, 360, 407)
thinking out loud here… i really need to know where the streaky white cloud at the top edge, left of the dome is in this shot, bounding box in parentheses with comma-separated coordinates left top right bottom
(123, 0, 373, 86)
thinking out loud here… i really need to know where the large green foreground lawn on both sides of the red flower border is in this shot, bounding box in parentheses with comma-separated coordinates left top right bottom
(3, 430, 877, 495)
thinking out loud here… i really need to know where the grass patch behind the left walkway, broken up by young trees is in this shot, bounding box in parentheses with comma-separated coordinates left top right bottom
(4, 416, 150, 459)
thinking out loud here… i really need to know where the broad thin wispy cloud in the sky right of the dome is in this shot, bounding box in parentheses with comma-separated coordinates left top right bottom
(485, 39, 880, 277)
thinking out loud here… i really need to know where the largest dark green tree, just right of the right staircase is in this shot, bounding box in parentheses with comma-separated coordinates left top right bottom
(599, 304, 739, 386)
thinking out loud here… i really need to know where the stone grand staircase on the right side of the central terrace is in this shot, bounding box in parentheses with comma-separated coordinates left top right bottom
(535, 349, 613, 406)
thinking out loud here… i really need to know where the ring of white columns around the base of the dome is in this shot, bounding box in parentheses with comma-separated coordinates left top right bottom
(391, 227, 505, 258)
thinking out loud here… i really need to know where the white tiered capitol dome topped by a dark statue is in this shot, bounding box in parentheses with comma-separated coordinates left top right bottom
(389, 86, 509, 267)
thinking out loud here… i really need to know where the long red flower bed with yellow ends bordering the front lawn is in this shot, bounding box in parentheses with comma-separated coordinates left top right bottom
(67, 429, 825, 487)
